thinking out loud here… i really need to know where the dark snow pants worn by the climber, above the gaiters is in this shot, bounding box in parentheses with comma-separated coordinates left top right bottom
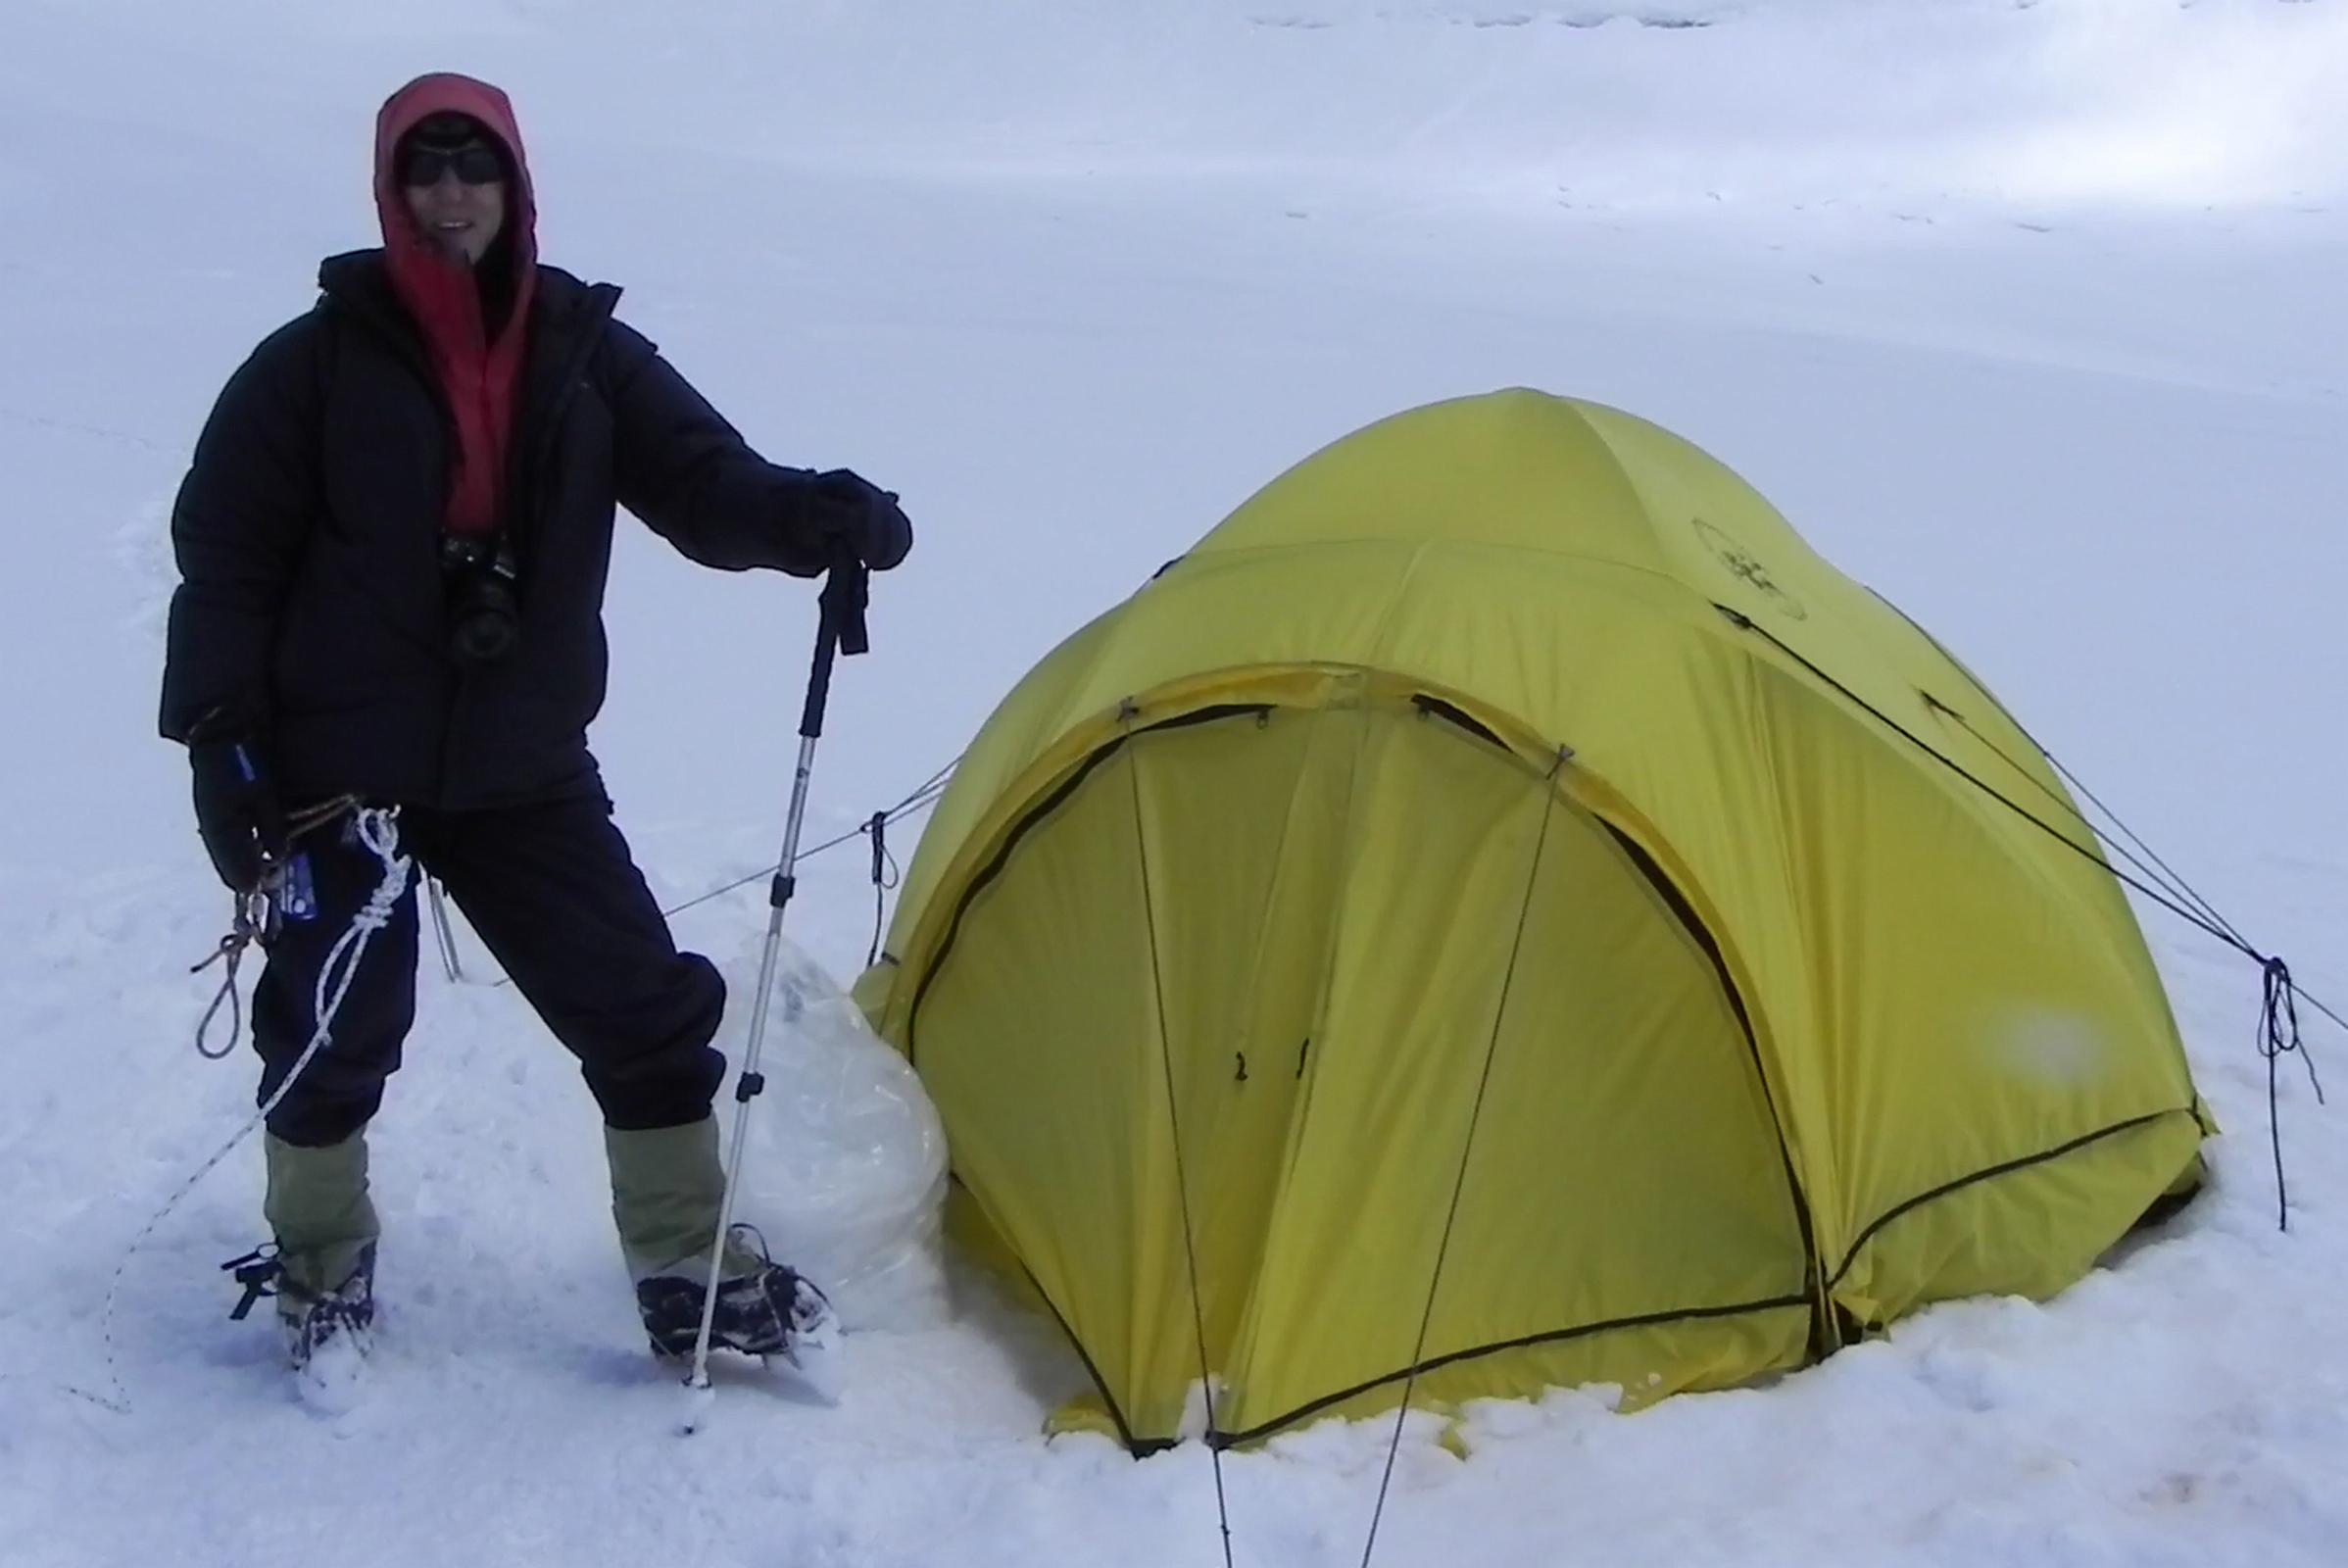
(254, 796, 725, 1148)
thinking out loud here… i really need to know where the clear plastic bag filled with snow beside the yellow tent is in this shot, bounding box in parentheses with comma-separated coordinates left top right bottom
(718, 937, 947, 1329)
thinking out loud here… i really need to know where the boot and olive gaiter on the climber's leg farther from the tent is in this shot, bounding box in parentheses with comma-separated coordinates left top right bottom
(263, 1131, 380, 1368)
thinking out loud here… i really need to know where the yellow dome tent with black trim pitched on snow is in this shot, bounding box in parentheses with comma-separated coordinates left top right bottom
(859, 390, 2212, 1450)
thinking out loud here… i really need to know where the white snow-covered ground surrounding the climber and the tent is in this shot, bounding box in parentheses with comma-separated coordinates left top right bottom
(0, 0, 2348, 1568)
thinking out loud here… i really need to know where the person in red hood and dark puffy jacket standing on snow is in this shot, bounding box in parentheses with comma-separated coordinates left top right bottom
(162, 75, 911, 1364)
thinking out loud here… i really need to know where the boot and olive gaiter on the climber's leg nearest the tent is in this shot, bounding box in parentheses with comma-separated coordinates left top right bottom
(604, 1117, 838, 1371)
